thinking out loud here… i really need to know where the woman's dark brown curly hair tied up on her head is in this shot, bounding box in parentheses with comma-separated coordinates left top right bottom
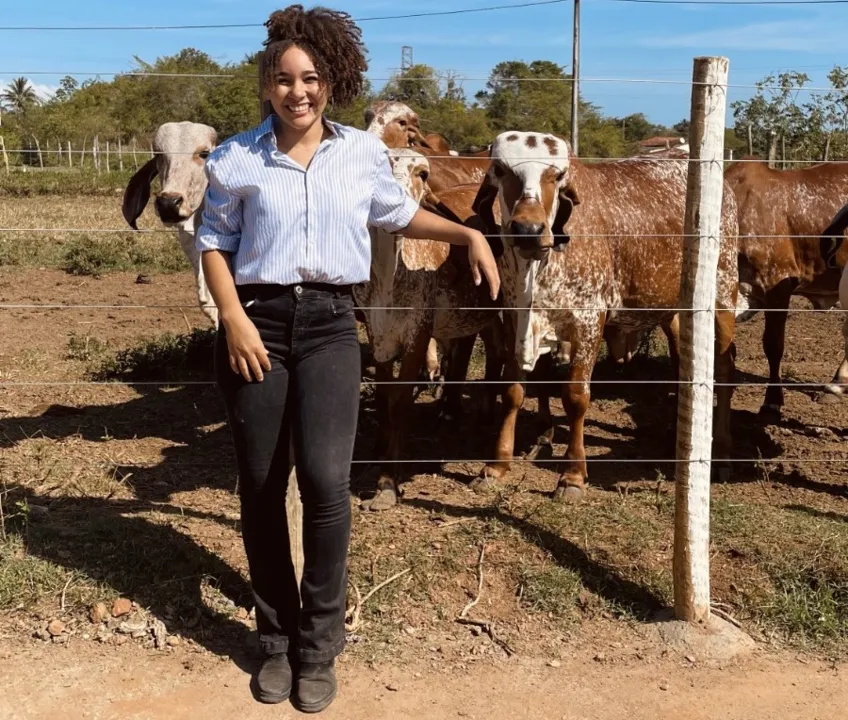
(264, 5, 368, 106)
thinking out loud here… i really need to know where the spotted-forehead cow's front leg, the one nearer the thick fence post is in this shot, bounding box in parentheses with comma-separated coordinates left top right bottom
(554, 314, 605, 502)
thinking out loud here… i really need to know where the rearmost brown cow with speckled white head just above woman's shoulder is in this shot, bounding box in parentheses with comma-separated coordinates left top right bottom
(365, 101, 489, 193)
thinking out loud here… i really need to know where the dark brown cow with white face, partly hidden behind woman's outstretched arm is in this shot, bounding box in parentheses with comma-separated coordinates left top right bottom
(355, 148, 497, 510)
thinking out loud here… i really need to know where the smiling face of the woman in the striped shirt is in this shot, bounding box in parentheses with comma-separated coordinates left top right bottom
(265, 46, 329, 134)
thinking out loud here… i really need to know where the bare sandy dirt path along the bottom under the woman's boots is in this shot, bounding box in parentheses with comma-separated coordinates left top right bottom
(0, 645, 848, 720)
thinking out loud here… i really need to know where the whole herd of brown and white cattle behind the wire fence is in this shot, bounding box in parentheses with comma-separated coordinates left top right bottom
(117, 102, 848, 510)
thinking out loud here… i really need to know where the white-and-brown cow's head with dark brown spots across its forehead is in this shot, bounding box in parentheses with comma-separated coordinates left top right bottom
(473, 132, 580, 260)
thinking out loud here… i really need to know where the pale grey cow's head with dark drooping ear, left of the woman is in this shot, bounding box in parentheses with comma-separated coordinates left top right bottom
(122, 122, 217, 230)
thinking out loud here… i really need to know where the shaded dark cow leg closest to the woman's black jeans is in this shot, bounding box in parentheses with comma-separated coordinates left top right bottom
(369, 330, 430, 511)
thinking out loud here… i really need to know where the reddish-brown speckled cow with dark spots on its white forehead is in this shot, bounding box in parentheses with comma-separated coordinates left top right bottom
(475, 132, 738, 498)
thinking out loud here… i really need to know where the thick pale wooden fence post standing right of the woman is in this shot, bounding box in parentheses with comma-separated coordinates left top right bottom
(674, 57, 729, 623)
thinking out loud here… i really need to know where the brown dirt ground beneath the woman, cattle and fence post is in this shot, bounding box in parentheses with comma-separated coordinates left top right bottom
(0, 222, 848, 720)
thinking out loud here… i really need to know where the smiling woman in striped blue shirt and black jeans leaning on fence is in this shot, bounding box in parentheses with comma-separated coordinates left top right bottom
(197, 5, 500, 712)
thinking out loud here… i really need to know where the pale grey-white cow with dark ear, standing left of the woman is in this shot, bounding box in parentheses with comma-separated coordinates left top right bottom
(122, 122, 218, 327)
